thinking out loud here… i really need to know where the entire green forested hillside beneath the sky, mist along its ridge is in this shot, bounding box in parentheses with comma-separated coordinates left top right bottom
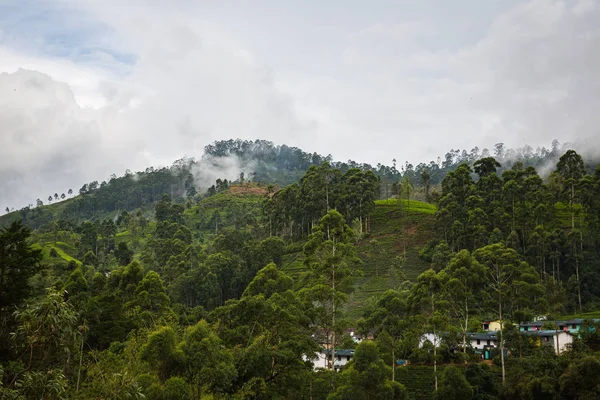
(0, 139, 600, 400)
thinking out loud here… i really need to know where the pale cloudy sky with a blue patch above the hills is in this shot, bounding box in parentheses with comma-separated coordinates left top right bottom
(0, 0, 600, 210)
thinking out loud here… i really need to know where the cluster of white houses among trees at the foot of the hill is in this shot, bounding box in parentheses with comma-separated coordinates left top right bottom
(313, 318, 600, 370)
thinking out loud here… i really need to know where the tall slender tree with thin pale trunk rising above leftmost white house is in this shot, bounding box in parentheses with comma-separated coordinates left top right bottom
(303, 210, 357, 369)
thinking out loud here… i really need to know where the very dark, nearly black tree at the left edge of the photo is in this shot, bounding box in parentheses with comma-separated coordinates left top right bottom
(0, 221, 42, 319)
